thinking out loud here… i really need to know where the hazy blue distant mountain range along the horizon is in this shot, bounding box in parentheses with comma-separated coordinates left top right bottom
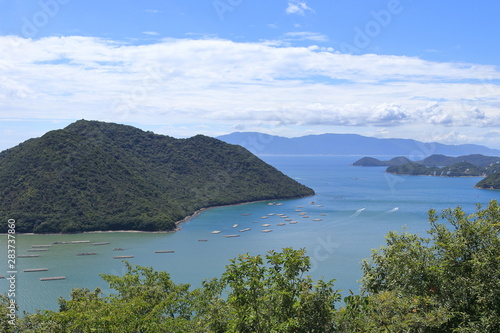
(217, 132, 500, 159)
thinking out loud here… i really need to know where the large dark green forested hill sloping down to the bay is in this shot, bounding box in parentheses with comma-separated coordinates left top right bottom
(0, 120, 314, 233)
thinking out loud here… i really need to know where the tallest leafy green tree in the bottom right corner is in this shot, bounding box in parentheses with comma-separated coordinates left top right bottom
(362, 200, 500, 332)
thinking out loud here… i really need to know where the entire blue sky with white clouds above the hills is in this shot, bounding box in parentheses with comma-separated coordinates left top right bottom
(0, 0, 500, 150)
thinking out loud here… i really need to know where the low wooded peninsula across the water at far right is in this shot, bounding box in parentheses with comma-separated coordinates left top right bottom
(353, 154, 500, 189)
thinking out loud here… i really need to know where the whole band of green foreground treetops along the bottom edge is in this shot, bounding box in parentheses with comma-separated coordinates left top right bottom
(4, 201, 500, 333)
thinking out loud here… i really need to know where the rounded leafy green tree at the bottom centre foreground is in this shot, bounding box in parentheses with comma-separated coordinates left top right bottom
(200, 248, 340, 333)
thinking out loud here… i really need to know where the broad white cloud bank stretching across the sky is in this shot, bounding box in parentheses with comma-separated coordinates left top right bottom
(0, 34, 500, 147)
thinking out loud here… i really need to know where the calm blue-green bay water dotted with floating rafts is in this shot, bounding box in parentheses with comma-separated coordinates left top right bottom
(0, 156, 500, 312)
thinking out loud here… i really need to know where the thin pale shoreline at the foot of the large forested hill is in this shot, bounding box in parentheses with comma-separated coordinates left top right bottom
(0, 193, 316, 236)
